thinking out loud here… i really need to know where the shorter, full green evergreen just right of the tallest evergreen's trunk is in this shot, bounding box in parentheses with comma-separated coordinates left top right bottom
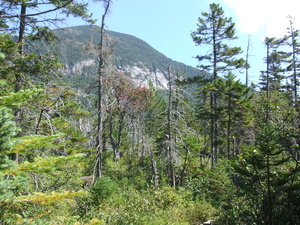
(197, 73, 253, 161)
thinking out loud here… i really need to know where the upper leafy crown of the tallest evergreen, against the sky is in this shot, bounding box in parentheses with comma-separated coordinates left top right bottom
(192, 3, 245, 79)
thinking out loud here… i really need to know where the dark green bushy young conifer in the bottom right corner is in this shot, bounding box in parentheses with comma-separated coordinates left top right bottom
(234, 124, 299, 224)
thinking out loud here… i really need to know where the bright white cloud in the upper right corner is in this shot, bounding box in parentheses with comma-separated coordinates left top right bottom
(223, 0, 300, 37)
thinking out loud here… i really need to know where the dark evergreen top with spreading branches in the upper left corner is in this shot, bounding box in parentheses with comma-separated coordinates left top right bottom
(0, 0, 92, 92)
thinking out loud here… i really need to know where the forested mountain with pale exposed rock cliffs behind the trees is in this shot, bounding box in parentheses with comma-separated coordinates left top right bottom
(54, 26, 199, 88)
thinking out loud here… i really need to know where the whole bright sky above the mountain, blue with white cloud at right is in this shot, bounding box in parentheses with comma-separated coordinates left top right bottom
(70, 0, 300, 82)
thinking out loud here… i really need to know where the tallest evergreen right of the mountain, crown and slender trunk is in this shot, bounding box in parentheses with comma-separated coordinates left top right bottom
(192, 3, 245, 163)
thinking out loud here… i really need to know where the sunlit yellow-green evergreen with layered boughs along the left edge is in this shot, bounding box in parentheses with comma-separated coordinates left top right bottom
(0, 34, 90, 224)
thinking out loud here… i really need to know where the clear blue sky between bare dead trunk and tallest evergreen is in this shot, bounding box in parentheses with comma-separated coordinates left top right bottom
(86, 0, 209, 66)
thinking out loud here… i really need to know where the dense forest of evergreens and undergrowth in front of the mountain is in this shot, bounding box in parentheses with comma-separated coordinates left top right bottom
(0, 0, 300, 225)
